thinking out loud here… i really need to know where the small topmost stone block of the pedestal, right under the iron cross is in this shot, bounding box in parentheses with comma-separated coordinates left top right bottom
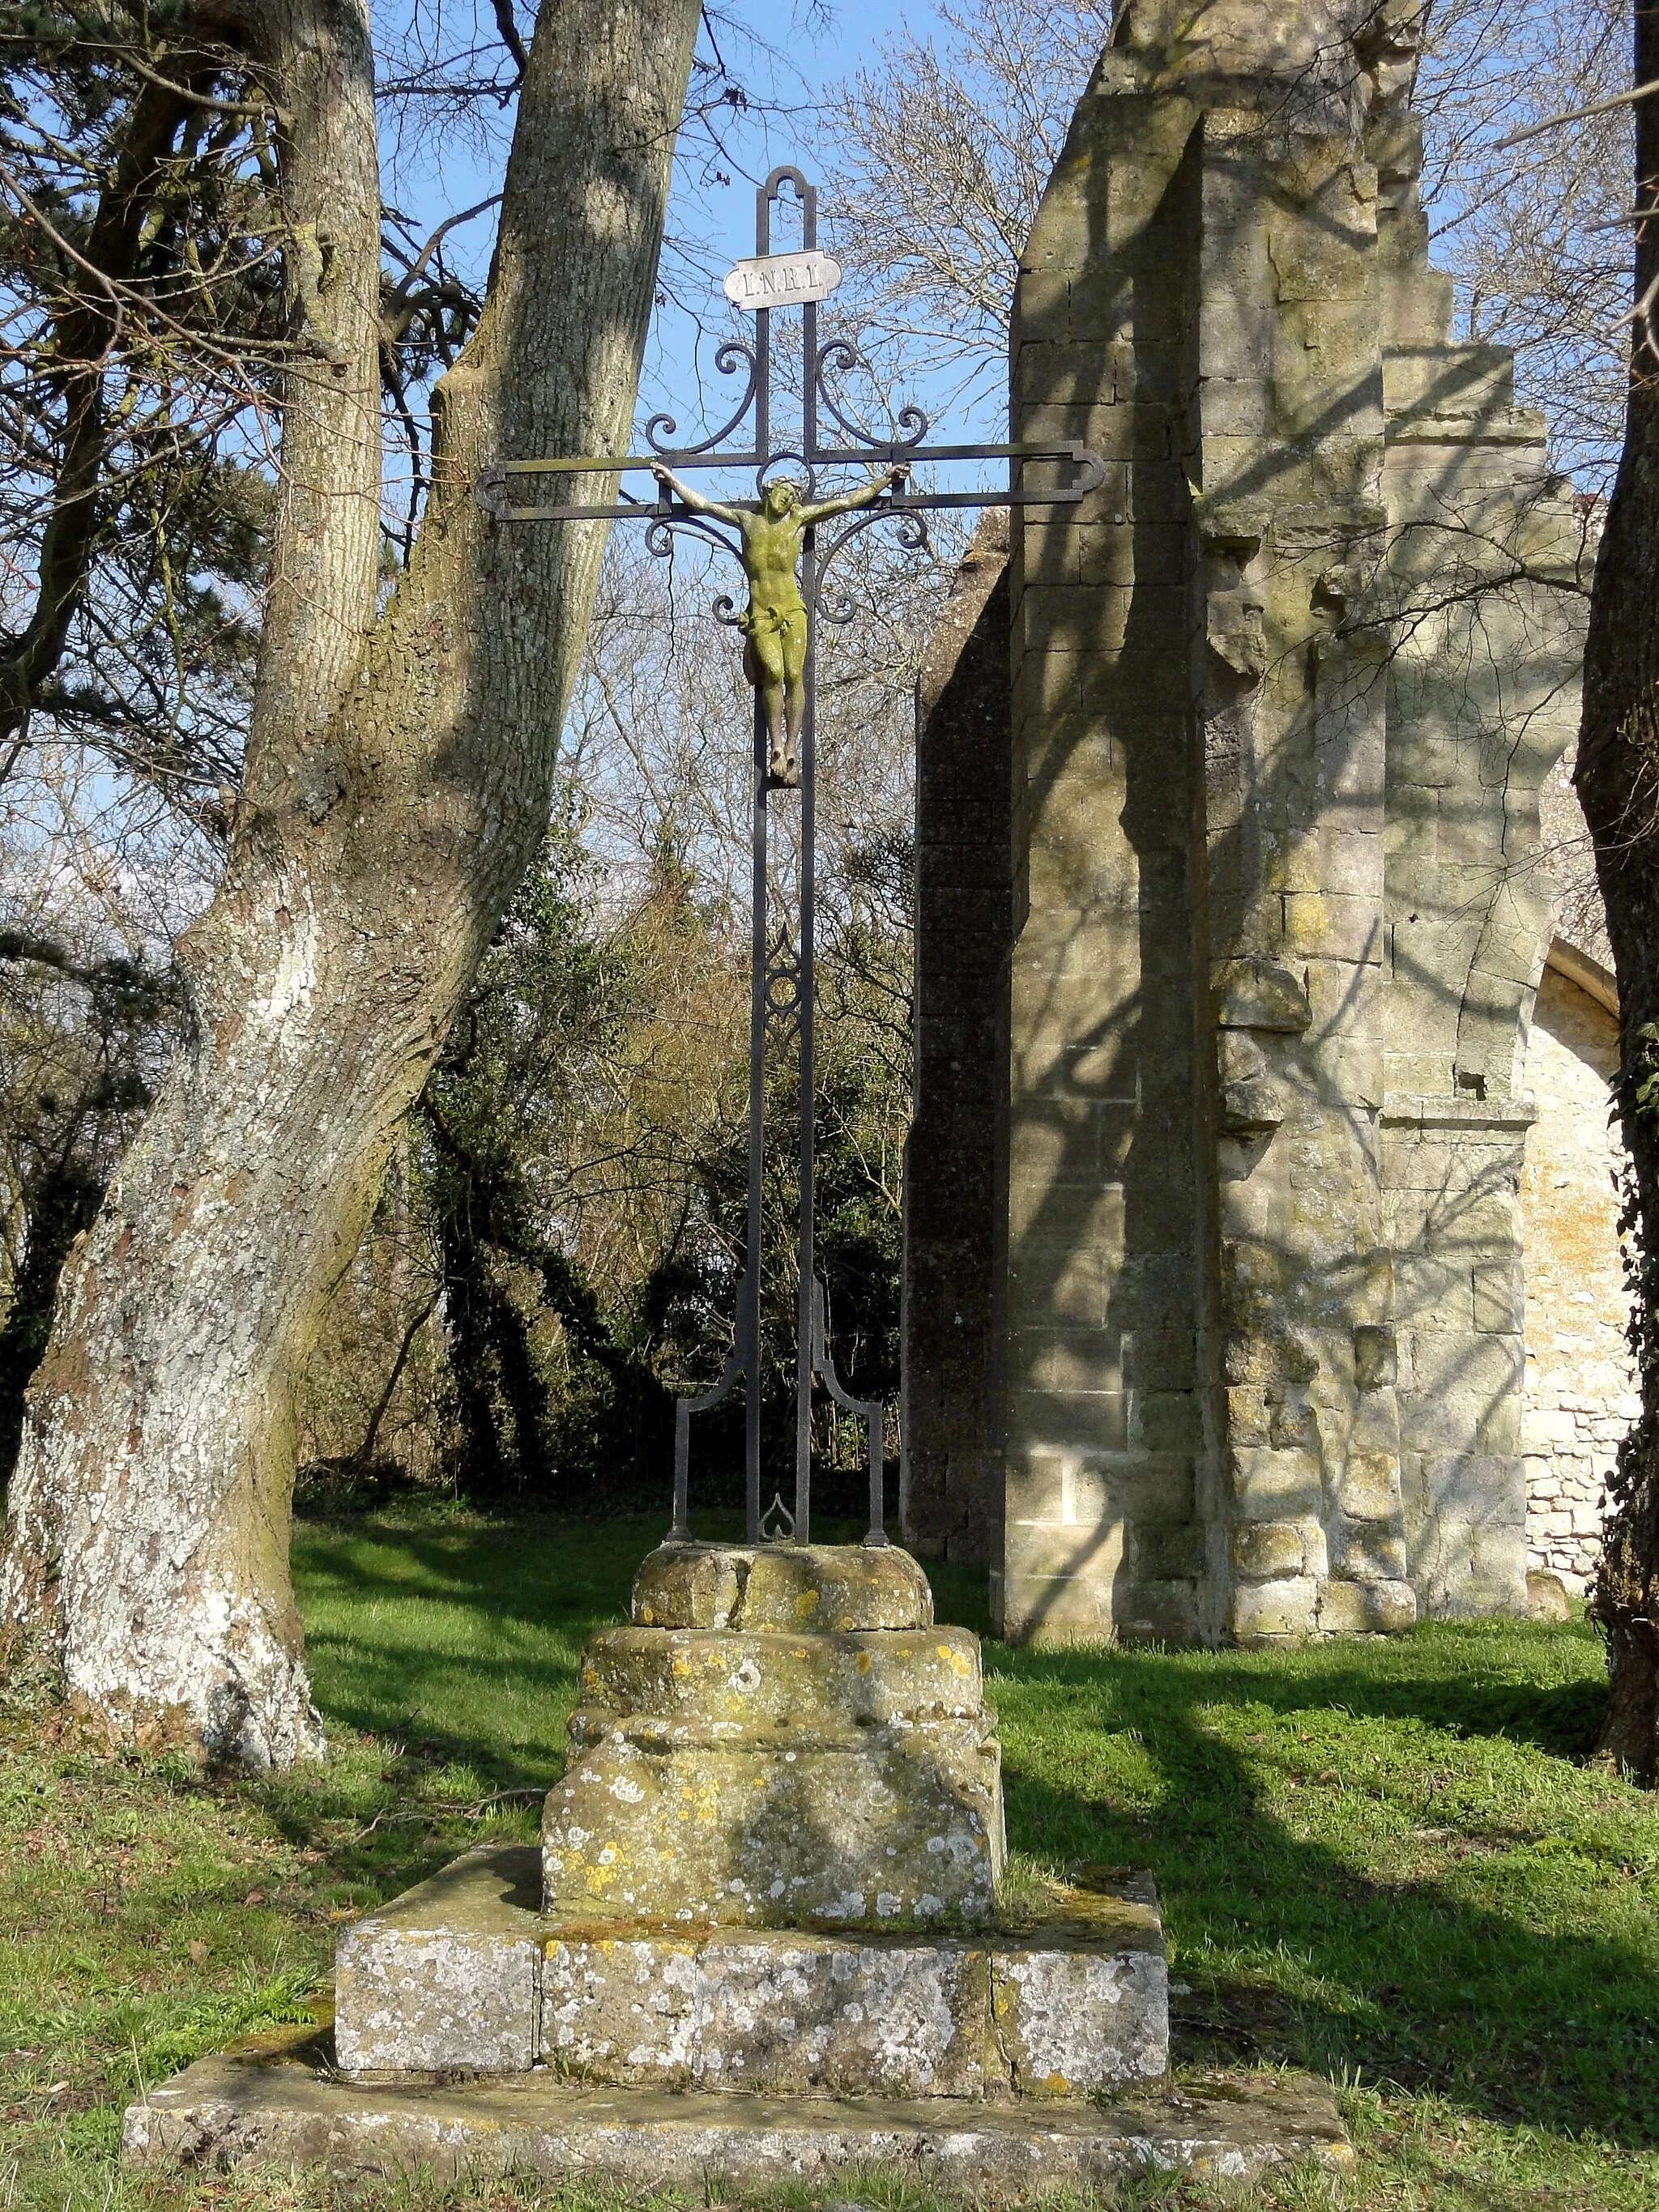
(633, 1544, 933, 1634)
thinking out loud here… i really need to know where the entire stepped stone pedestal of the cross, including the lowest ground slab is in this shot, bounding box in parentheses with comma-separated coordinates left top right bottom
(126, 1544, 1345, 2185)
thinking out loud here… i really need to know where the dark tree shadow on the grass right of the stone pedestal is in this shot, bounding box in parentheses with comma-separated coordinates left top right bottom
(1006, 1650, 1659, 2150)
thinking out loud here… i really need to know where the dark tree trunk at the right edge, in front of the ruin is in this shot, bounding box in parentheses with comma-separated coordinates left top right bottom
(1575, 6, 1659, 1776)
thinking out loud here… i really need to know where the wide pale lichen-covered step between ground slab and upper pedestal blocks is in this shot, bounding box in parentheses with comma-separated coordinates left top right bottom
(336, 1849, 1168, 2099)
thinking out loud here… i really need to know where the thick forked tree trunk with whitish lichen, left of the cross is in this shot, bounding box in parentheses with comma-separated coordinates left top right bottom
(0, 0, 699, 1763)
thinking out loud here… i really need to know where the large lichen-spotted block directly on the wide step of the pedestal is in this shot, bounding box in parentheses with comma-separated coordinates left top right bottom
(552, 1710, 1002, 1929)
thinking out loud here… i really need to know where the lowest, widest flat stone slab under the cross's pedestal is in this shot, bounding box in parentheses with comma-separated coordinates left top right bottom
(122, 2031, 1354, 2199)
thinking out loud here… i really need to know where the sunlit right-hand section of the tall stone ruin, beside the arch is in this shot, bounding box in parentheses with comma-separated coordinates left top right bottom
(1380, 151, 1589, 1615)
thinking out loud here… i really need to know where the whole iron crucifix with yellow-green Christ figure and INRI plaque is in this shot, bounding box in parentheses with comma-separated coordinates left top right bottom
(473, 166, 1106, 1544)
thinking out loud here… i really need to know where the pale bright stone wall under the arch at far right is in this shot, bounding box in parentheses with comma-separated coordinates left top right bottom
(1520, 965, 1641, 1592)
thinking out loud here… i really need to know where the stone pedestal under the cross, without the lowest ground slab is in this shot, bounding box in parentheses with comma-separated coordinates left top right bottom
(336, 1544, 1168, 2099)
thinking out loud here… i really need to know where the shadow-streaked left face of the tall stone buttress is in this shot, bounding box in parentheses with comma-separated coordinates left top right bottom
(993, 56, 1210, 1641)
